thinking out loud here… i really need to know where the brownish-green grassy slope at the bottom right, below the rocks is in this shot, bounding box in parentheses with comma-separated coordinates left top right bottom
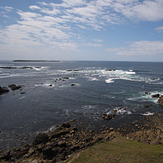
(66, 137, 163, 163)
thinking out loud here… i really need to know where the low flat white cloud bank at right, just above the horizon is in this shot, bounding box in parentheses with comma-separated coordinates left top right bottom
(107, 41, 163, 56)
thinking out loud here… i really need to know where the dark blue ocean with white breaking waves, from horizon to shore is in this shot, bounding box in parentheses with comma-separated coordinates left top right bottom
(0, 61, 163, 148)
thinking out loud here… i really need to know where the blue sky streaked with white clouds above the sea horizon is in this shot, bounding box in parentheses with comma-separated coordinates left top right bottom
(0, 0, 163, 62)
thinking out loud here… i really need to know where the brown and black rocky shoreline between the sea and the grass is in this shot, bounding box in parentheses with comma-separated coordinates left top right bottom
(0, 115, 163, 163)
